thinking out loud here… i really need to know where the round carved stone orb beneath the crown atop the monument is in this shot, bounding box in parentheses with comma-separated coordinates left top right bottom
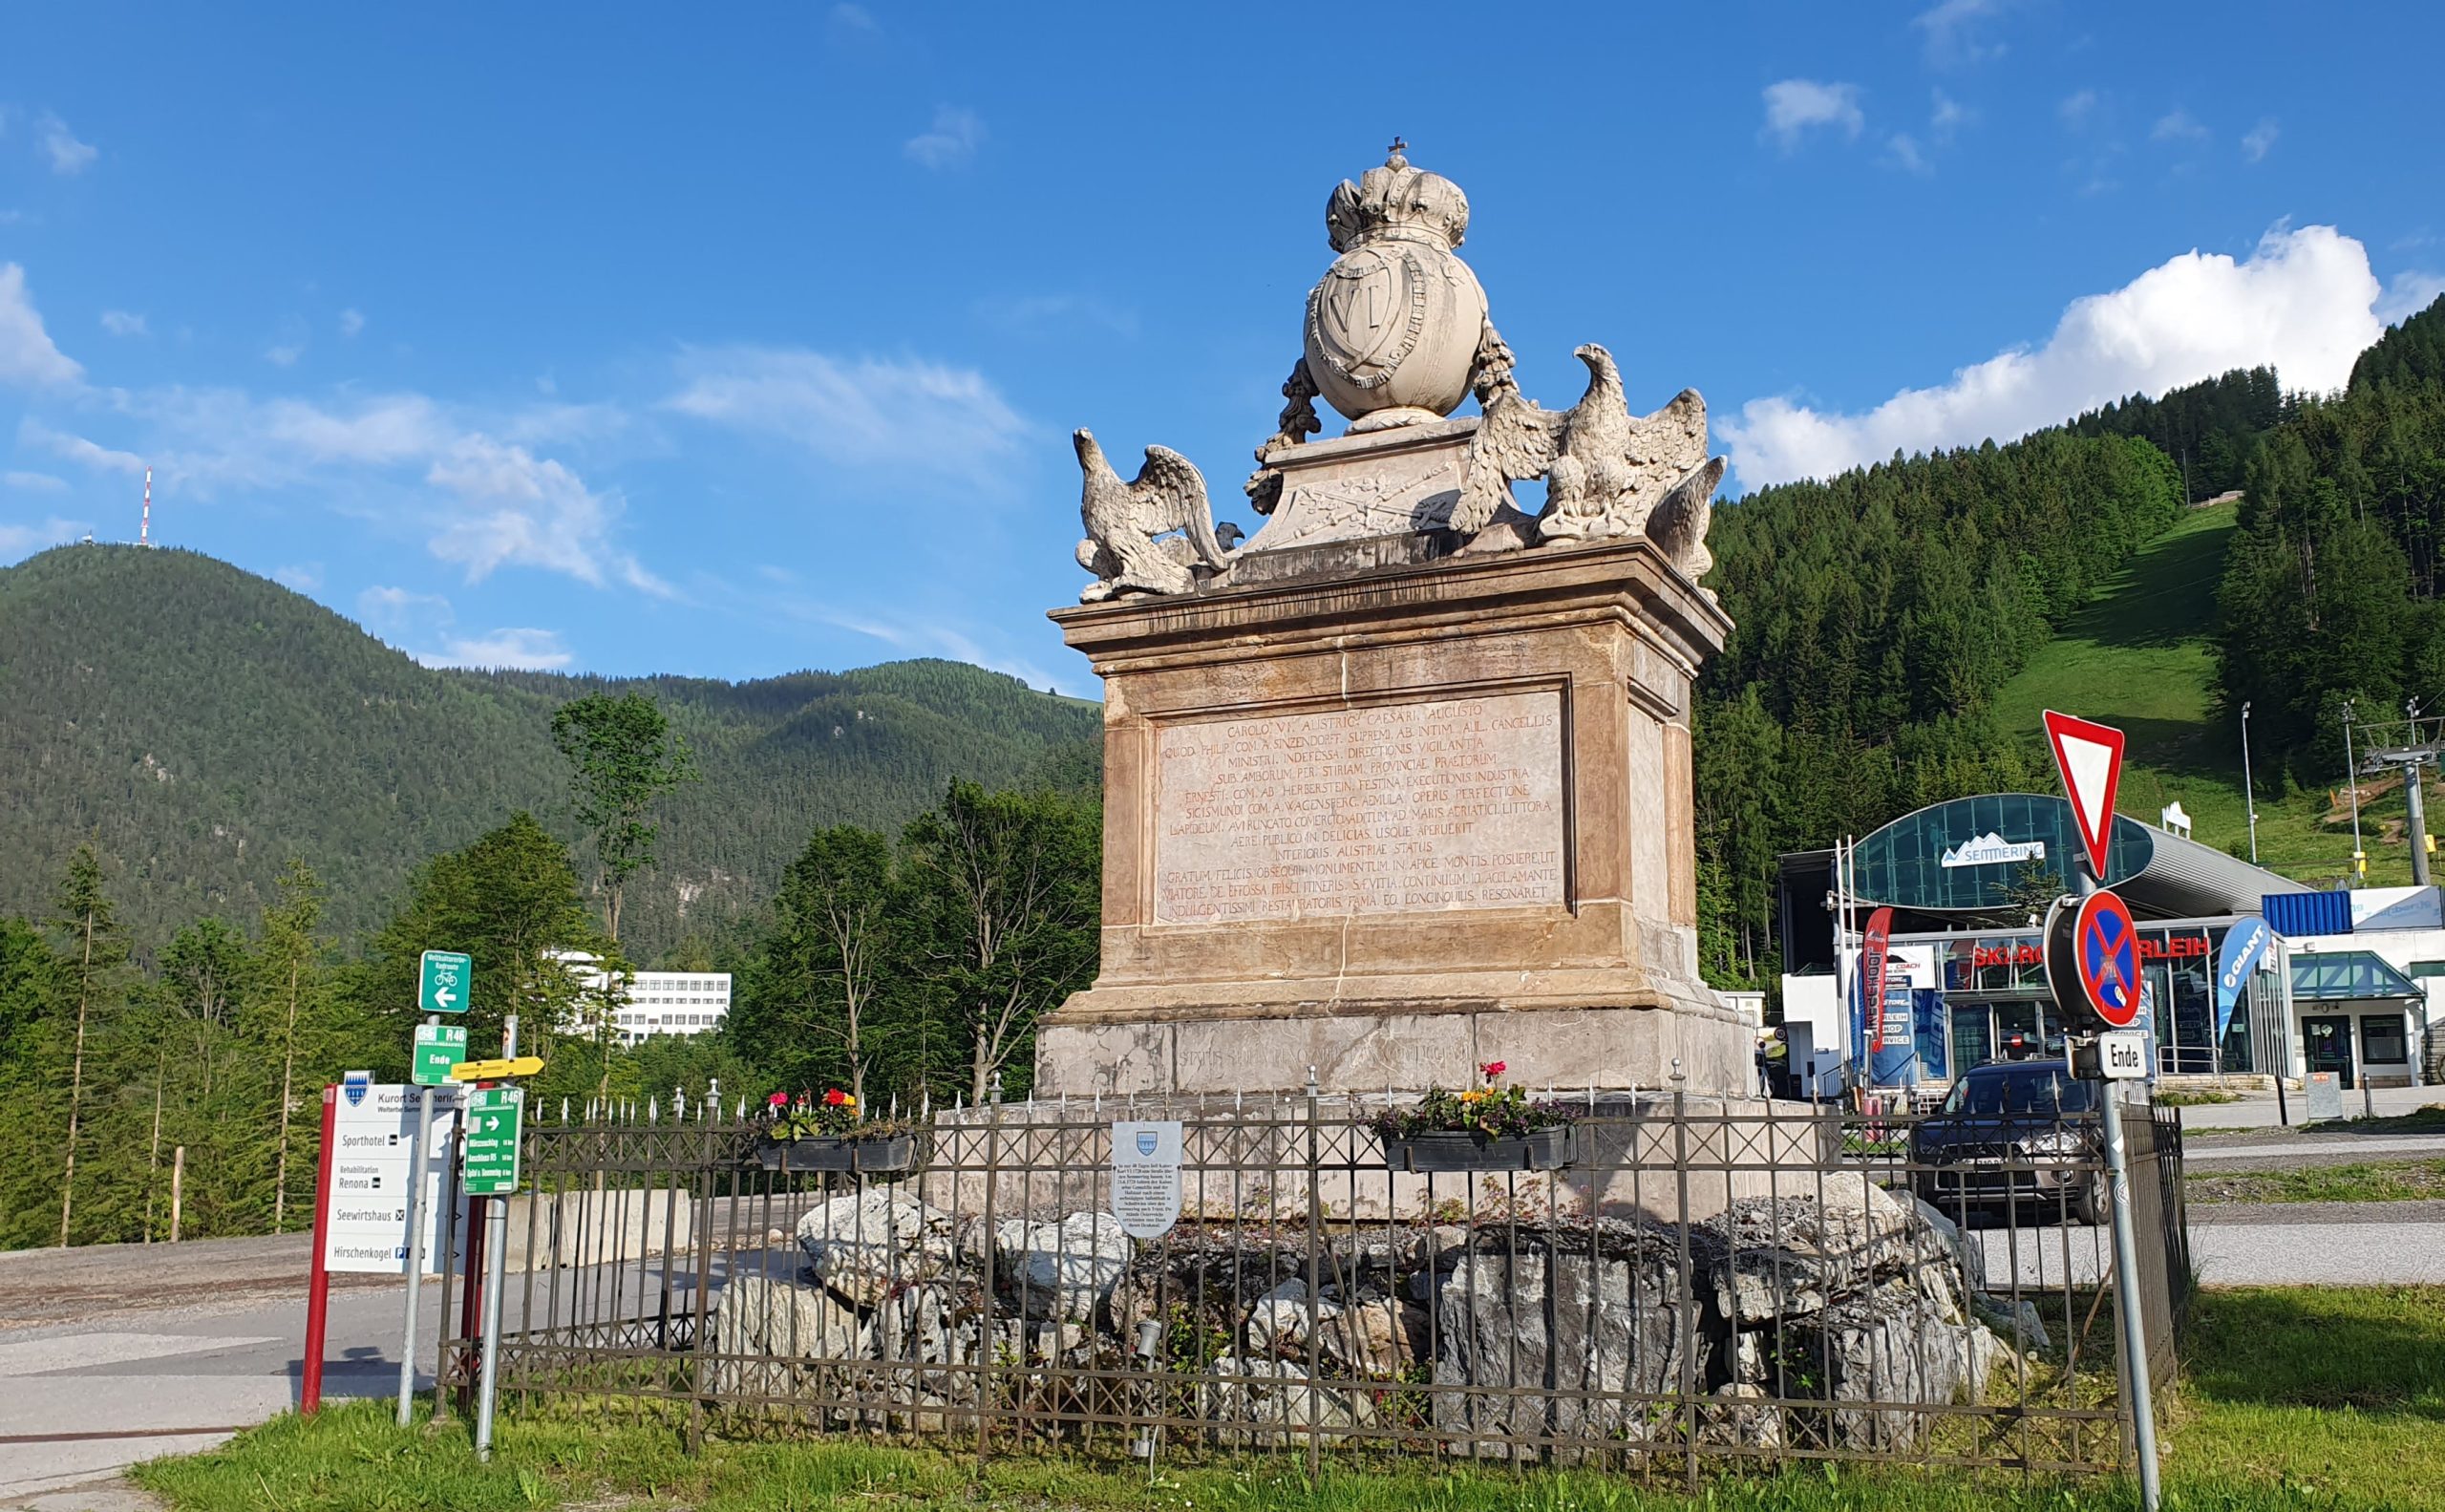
(1308, 235, 1486, 421)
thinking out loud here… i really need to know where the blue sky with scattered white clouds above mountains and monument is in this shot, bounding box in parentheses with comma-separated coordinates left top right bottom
(0, 0, 2445, 692)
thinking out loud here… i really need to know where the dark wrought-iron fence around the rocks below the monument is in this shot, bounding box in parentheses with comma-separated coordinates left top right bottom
(440, 1094, 2191, 1482)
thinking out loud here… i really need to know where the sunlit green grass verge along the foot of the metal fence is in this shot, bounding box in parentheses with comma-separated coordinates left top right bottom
(135, 1287, 2445, 1512)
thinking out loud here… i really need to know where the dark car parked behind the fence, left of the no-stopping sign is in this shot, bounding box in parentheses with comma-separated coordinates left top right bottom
(1909, 1059, 2105, 1224)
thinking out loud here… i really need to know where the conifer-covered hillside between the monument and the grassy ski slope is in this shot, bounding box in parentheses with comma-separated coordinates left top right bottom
(1697, 431, 2183, 981)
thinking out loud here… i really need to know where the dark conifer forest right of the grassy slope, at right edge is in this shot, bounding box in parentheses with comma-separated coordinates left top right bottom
(2218, 299, 2445, 763)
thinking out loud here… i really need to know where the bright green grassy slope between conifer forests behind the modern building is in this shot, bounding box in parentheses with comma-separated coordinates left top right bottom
(1995, 504, 2437, 885)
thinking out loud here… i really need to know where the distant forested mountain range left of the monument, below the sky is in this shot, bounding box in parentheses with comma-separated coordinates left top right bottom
(0, 545, 1100, 962)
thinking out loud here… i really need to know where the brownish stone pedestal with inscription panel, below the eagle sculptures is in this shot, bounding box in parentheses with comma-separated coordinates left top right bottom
(1036, 531, 1754, 1097)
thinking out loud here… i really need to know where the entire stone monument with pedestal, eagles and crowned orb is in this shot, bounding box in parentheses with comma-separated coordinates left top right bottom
(1036, 142, 1751, 1097)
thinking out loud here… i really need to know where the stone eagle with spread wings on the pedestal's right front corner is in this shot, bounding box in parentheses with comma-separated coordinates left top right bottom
(1453, 343, 1721, 570)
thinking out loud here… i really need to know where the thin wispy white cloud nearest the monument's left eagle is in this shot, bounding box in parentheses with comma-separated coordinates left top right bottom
(668, 348, 1027, 475)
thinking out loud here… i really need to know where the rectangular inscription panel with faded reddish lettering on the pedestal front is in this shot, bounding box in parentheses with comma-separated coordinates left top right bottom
(1154, 692, 1564, 925)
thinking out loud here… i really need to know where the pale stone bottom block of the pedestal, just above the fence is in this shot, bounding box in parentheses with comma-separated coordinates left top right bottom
(1034, 1006, 1755, 1098)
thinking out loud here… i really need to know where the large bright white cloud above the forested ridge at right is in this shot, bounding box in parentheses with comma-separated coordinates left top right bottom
(1724, 225, 2379, 487)
